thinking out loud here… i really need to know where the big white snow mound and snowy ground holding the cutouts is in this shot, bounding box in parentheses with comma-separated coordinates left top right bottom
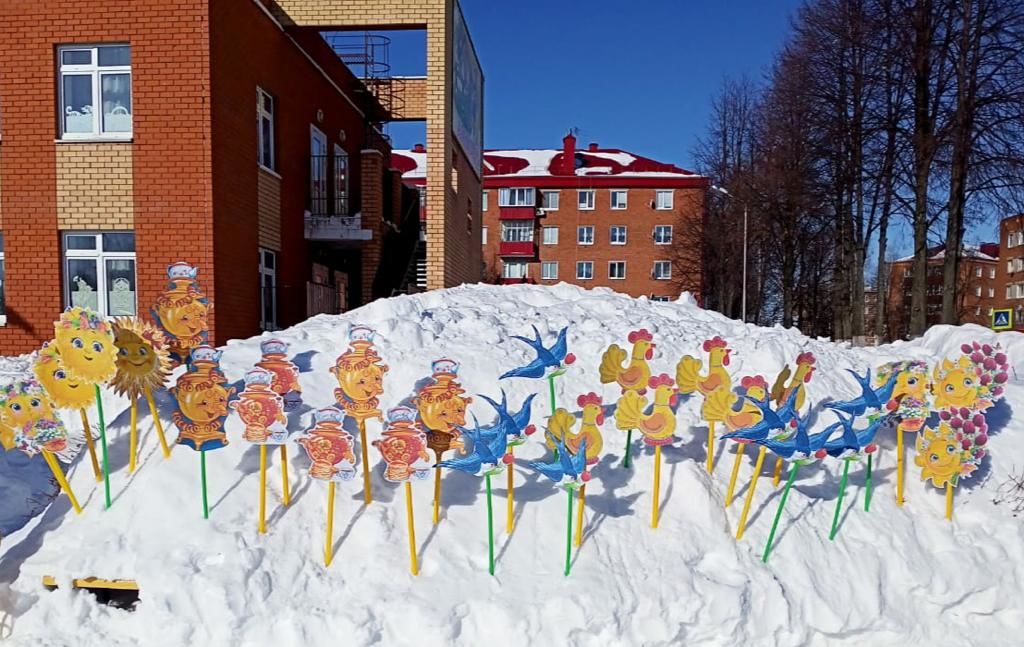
(0, 285, 1024, 647)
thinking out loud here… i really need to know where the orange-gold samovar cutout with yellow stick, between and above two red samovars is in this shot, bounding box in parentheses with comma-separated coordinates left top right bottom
(331, 326, 388, 505)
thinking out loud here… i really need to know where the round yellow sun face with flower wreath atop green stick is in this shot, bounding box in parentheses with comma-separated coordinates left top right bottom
(53, 306, 118, 384)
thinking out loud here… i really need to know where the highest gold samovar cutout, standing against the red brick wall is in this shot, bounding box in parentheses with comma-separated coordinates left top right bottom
(151, 261, 213, 363)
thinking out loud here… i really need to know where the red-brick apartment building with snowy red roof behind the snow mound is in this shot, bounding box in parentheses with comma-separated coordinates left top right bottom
(391, 134, 709, 300)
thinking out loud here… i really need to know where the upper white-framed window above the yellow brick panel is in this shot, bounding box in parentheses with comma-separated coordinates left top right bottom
(57, 45, 132, 139)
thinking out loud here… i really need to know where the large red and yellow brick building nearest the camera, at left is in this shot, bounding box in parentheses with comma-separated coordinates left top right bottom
(0, 0, 482, 354)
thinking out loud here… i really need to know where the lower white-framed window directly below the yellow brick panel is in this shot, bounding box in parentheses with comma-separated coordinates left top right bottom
(63, 231, 135, 316)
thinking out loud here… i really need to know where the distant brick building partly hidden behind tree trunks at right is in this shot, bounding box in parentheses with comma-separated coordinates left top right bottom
(886, 243, 1004, 339)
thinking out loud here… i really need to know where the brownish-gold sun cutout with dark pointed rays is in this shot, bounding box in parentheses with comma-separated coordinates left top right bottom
(111, 316, 171, 398)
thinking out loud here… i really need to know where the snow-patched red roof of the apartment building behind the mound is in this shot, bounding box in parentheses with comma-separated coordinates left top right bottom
(391, 148, 701, 179)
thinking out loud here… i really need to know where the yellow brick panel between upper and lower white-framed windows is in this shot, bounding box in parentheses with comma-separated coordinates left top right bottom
(56, 143, 135, 229)
